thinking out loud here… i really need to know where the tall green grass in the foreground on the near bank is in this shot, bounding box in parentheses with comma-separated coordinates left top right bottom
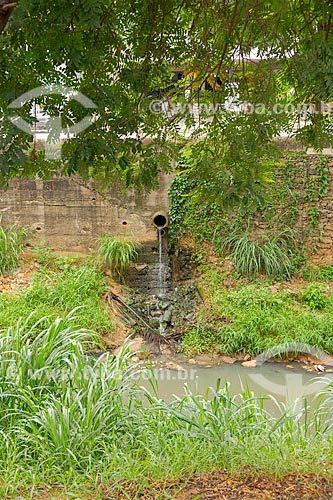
(0, 318, 333, 498)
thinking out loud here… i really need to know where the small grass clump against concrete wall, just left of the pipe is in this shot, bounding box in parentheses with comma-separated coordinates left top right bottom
(98, 235, 142, 281)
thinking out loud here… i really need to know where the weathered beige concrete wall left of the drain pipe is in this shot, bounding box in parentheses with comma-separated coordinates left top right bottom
(0, 175, 171, 252)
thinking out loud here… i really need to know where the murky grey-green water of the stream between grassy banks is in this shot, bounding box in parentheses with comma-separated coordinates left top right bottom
(138, 363, 333, 410)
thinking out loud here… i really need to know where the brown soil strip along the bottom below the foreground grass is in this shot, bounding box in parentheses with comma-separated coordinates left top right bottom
(19, 468, 333, 500)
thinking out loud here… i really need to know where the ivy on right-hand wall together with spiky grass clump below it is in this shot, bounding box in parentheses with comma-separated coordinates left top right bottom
(169, 153, 331, 279)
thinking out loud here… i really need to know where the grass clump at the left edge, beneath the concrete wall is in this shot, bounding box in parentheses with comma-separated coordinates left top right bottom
(0, 226, 27, 274)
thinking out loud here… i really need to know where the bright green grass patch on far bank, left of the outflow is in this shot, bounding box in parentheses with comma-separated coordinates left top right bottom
(0, 255, 114, 335)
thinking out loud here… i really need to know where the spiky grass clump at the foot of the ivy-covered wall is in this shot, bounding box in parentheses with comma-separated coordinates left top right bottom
(218, 228, 296, 278)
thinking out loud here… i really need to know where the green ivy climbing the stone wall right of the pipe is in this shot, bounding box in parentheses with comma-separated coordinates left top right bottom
(169, 153, 330, 278)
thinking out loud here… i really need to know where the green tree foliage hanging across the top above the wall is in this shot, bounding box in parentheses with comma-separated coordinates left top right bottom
(0, 0, 333, 203)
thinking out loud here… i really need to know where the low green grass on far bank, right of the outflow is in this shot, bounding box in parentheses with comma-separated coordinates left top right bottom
(183, 273, 333, 355)
